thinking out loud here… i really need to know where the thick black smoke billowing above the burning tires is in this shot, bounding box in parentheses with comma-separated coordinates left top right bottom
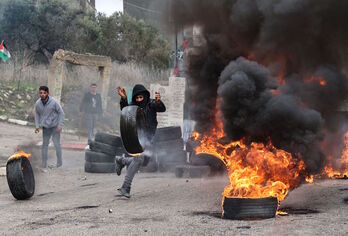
(171, 0, 348, 173)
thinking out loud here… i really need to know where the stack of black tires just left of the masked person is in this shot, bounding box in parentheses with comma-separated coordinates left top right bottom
(85, 133, 125, 173)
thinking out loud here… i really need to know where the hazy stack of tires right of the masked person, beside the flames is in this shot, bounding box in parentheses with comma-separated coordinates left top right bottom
(152, 126, 187, 172)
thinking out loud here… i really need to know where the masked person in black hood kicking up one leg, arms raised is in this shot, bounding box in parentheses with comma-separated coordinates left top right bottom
(116, 84, 166, 198)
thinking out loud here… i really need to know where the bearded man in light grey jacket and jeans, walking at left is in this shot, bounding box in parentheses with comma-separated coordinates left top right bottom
(35, 86, 64, 172)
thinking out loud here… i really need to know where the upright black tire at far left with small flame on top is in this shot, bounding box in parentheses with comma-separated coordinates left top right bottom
(6, 157, 35, 200)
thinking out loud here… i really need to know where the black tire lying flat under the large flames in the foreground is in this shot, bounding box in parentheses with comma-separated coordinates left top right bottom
(223, 197, 278, 220)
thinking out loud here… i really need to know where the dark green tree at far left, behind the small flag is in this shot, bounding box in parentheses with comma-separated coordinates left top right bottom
(0, 0, 87, 64)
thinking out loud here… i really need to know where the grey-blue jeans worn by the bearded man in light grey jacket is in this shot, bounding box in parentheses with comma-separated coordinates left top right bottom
(42, 127, 63, 168)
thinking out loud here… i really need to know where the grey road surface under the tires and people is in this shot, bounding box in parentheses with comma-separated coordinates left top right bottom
(0, 123, 348, 235)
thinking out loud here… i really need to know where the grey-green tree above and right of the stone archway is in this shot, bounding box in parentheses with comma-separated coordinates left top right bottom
(81, 13, 170, 69)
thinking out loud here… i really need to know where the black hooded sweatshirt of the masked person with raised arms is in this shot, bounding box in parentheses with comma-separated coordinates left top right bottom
(120, 84, 166, 139)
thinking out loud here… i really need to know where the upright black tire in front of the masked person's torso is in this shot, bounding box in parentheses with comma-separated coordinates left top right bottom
(120, 106, 147, 154)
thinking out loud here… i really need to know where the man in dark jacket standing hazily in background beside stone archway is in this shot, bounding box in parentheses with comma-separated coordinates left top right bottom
(80, 84, 103, 144)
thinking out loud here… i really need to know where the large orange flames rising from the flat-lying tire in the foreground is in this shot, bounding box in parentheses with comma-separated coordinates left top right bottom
(194, 121, 305, 201)
